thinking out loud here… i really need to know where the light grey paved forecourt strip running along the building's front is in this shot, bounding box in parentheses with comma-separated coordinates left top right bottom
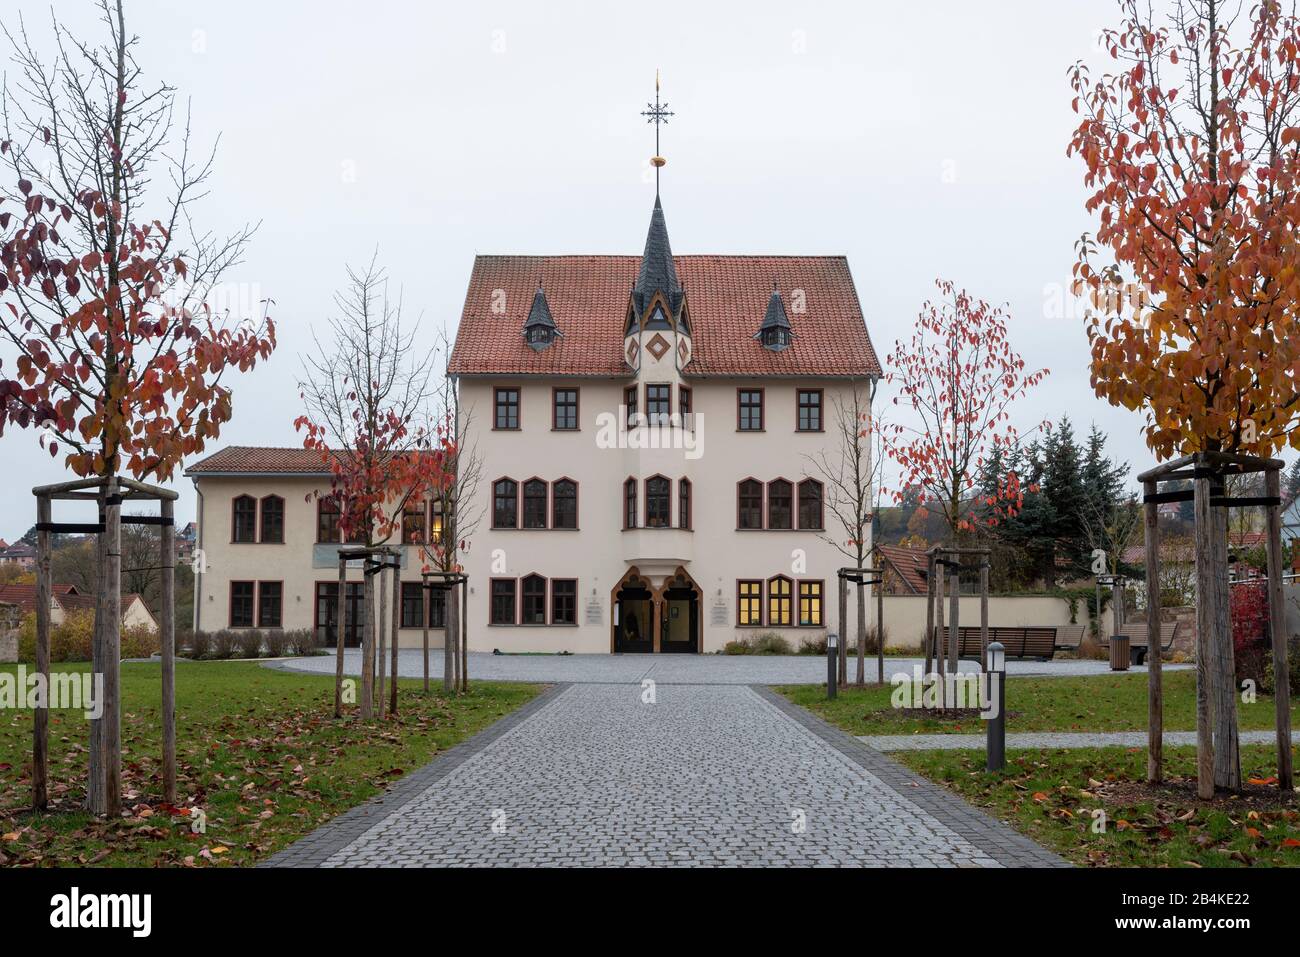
(267, 649, 1190, 684)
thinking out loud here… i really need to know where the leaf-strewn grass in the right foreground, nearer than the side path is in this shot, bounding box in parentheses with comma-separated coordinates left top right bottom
(892, 745, 1300, 867)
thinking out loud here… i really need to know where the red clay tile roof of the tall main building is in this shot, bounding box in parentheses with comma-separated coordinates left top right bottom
(450, 256, 880, 376)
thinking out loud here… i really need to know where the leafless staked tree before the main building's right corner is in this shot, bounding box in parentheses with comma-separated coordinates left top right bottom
(806, 380, 884, 685)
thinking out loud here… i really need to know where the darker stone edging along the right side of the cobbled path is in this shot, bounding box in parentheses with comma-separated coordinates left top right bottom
(750, 685, 1074, 867)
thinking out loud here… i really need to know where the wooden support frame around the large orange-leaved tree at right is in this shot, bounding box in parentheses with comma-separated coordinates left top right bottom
(1138, 451, 1295, 798)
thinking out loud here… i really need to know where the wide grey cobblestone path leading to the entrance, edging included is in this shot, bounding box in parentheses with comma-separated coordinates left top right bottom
(269, 681, 1063, 867)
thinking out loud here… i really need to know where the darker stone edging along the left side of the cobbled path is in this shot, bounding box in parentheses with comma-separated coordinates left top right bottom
(257, 683, 569, 867)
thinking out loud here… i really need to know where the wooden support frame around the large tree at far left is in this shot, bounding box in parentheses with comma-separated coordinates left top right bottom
(31, 476, 177, 818)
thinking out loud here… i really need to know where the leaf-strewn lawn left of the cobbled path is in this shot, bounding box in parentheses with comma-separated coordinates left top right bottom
(0, 661, 541, 866)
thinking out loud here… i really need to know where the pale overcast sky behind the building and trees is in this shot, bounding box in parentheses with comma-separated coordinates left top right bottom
(0, 0, 1180, 541)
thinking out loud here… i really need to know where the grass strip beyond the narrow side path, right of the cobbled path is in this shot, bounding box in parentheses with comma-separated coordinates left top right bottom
(776, 671, 1295, 735)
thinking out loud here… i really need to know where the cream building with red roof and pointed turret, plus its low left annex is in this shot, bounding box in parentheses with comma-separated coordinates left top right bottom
(186, 175, 881, 653)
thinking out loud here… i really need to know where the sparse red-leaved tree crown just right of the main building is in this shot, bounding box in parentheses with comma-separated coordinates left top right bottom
(880, 280, 1048, 545)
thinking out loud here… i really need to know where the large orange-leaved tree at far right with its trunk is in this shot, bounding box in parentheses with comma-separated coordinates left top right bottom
(1069, 0, 1300, 788)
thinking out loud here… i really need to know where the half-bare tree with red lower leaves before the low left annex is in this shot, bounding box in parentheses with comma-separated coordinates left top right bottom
(294, 259, 454, 719)
